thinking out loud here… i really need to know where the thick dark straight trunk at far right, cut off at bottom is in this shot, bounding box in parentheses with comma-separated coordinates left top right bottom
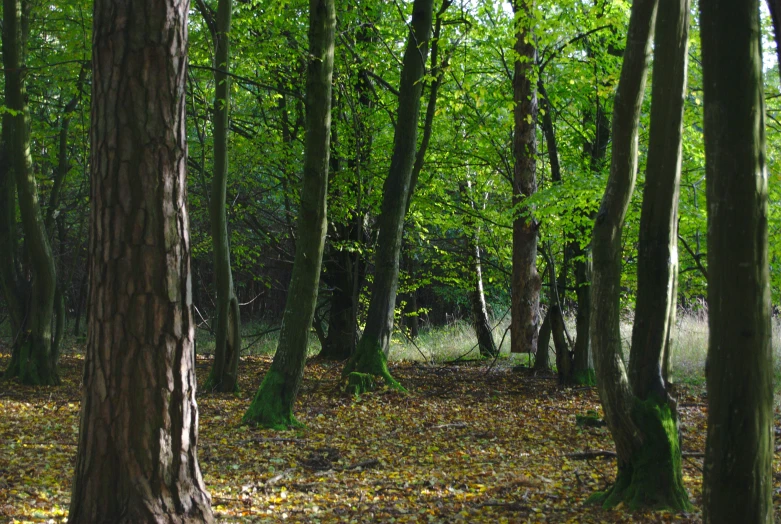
(700, 0, 773, 523)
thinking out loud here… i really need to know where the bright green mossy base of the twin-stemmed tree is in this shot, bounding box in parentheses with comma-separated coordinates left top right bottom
(589, 398, 691, 511)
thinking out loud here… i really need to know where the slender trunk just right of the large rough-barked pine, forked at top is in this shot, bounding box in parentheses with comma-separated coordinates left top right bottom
(197, 0, 241, 392)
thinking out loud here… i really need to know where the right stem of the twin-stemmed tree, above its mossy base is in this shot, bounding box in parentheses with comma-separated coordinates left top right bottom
(629, 0, 689, 400)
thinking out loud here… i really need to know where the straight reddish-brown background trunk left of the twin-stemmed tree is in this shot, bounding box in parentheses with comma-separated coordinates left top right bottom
(510, 1, 542, 353)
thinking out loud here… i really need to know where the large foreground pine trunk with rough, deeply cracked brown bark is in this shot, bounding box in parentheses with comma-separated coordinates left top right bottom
(68, 0, 213, 524)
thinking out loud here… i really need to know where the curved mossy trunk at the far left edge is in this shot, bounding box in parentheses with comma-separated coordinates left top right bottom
(3, 0, 59, 385)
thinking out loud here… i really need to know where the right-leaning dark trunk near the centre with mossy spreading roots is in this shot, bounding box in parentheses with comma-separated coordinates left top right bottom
(342, 0, 433, 390)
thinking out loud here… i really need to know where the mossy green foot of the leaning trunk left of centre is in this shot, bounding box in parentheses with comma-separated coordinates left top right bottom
(241, 367, 304, 430)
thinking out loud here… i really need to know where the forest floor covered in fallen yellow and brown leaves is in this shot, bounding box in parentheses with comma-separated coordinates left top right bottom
(0, 348, 779, 523)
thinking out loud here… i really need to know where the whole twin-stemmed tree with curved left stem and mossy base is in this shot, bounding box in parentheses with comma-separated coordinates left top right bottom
(591, 0, 689, 510)
